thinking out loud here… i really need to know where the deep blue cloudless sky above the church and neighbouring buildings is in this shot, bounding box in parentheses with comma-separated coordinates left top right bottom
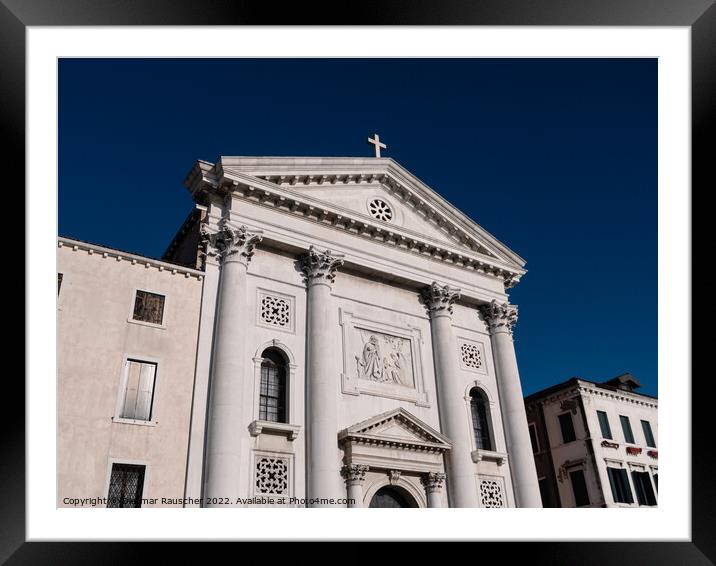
(59, 59, 657, 395)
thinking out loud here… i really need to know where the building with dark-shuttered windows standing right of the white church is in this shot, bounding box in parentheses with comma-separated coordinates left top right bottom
(525, 373, 659, 507)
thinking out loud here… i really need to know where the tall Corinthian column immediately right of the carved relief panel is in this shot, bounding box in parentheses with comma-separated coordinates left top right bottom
(422, 282, 478, 507)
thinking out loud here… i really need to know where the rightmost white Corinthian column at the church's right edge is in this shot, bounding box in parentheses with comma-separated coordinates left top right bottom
(480, 300, 542, 507)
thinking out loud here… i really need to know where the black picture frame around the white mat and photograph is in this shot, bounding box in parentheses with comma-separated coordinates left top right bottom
(5, 0, 716, 565)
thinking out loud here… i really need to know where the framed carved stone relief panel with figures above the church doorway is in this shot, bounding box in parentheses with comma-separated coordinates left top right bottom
(341, 309, 428, 407)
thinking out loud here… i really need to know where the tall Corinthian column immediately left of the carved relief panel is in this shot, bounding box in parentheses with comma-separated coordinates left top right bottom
(300, 246, 345, 507)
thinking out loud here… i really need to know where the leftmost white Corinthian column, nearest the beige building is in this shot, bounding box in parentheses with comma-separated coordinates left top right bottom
(202, 219, 262, 506)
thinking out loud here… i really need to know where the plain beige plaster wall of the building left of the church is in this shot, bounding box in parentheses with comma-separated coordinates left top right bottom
(57, 239, 202, 506)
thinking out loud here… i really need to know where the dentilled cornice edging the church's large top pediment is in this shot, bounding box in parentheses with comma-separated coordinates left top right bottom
(185, 157, 525, 288)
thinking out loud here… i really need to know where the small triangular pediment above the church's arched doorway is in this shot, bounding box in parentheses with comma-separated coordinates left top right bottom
(338, 407, 451, 450)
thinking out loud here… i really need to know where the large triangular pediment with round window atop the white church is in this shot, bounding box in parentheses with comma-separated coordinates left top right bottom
(210, 157, 525, 272)
